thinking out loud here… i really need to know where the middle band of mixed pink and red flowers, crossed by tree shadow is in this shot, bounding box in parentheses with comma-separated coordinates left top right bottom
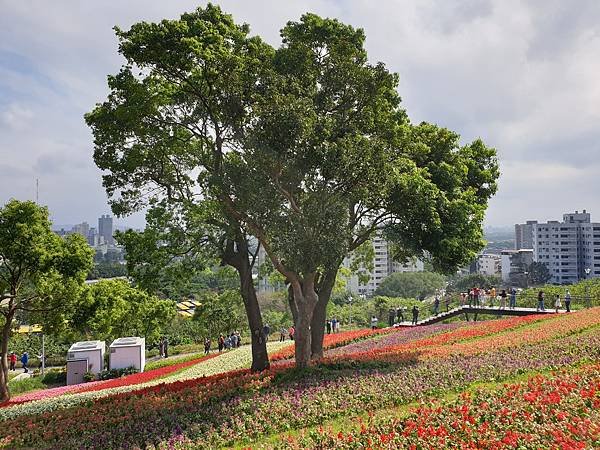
(0, 320, 600, 448)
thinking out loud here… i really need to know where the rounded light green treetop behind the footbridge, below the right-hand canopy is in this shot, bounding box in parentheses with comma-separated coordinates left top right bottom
(375, 272, 446, 299)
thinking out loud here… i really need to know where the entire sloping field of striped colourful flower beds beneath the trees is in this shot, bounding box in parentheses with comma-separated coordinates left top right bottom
(0, 308, 600, 449)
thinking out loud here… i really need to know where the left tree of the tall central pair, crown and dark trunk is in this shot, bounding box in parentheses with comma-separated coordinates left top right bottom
(86, 4, 273, 370)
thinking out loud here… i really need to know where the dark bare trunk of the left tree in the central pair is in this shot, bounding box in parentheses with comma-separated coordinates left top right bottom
(223, 234, 270, 372)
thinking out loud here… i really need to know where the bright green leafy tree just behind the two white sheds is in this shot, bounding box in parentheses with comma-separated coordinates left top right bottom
(72, 280, 176, 341)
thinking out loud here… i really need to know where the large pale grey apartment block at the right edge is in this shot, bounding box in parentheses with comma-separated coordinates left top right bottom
(533, 209, 600, 284)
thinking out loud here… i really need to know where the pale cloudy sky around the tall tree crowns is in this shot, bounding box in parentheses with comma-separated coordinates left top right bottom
(0, 0, 600, 227)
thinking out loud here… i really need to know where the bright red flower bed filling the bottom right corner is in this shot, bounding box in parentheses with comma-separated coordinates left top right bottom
(275, 363, 600, 450)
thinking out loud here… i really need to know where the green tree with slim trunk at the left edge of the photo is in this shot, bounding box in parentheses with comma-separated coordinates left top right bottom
(0, 200, 93, 402)
